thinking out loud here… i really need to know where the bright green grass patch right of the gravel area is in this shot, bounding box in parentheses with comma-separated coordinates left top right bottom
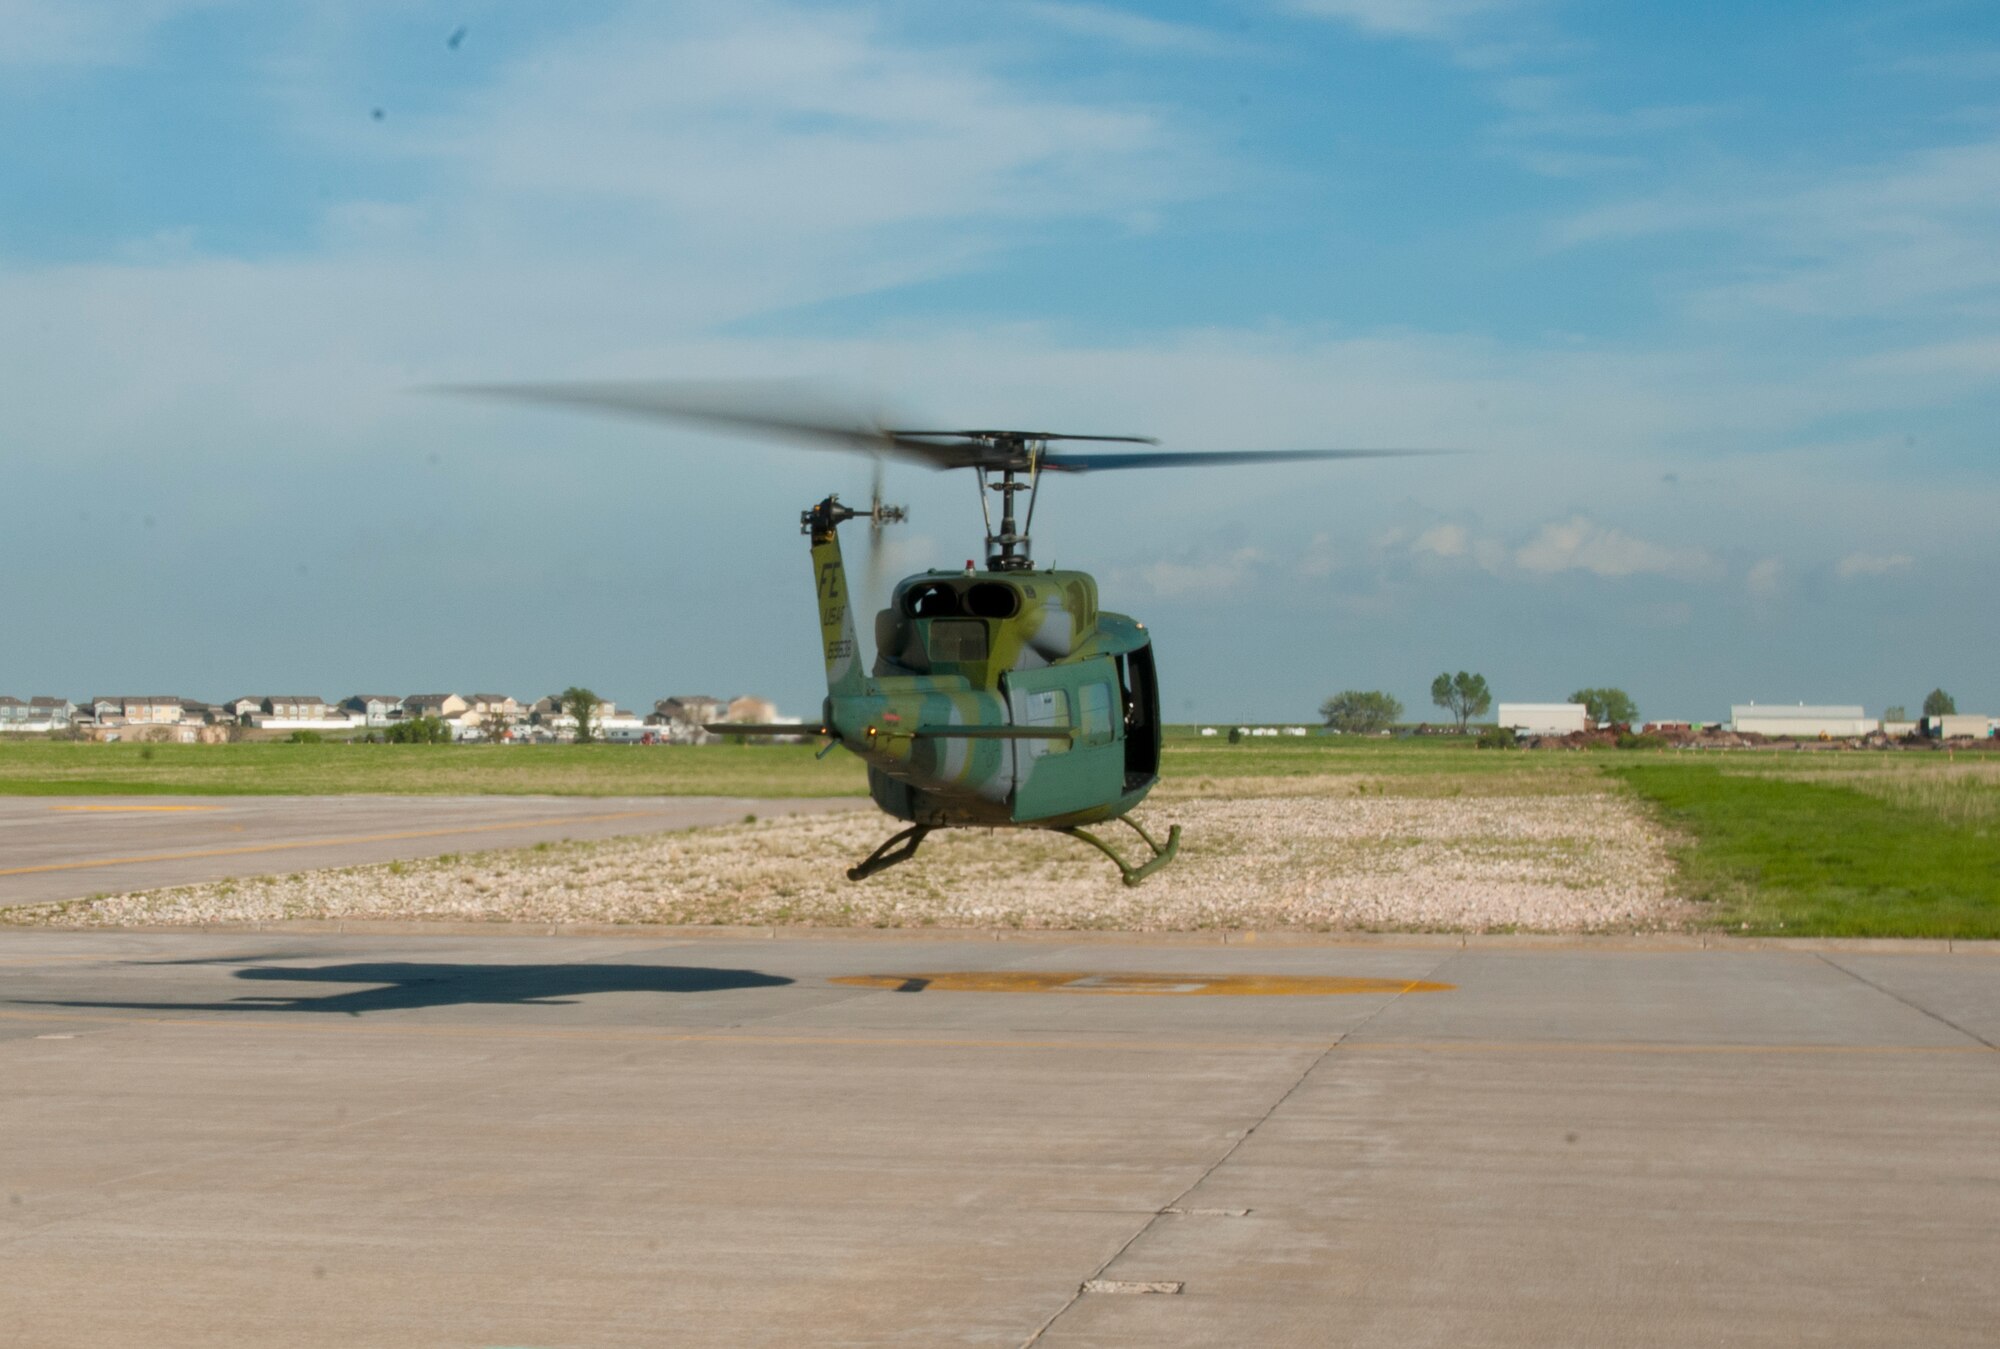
(1608, 757, 2000, 939)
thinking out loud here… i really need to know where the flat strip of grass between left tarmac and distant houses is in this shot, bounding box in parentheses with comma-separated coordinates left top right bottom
(0, 741, 868, 797)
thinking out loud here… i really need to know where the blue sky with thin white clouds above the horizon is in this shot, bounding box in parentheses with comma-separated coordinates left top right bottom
(0, 0, 2000, 719)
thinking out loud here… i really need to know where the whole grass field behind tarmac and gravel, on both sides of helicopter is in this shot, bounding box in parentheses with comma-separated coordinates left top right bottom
(0, 735, 2000, 939)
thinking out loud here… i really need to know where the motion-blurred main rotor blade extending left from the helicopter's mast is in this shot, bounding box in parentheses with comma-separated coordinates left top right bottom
(434, 380, 984, 468)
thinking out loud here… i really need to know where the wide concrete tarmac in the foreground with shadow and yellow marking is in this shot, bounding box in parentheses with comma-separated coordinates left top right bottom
(0, 931, 2000, 1349)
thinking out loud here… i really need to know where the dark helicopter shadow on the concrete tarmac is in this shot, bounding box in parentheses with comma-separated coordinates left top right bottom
(21, 961, 794, 1017)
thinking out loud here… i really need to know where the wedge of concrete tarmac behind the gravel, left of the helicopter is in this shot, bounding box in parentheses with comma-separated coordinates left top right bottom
(0, 797, 868, 907)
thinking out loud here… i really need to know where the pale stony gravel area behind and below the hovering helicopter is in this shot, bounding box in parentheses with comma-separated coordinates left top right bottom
(4, 783, 1688, 933)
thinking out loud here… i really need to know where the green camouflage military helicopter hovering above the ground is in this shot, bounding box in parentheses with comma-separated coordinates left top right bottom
(440, 382, 1444, 885)
